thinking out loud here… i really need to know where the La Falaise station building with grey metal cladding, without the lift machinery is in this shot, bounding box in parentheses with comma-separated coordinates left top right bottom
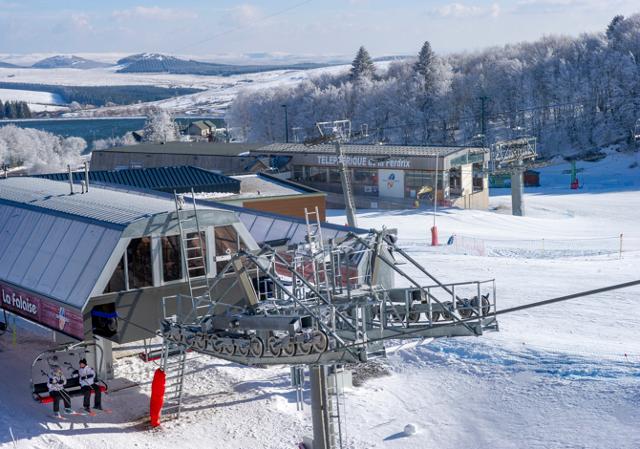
(0, 177, 346, 371)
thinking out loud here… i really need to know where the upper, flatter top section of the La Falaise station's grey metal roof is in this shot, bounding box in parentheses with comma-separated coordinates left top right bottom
(0, 177, 190, 228)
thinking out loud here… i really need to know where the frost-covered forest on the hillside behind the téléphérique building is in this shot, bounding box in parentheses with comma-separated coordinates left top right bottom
(227, 14, 640, 155)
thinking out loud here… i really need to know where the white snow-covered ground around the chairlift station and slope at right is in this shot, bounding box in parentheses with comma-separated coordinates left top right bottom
(0, 153, 640, 449)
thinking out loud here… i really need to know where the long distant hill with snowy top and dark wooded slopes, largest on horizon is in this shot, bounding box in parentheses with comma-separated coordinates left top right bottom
(117, 53, 329, 76)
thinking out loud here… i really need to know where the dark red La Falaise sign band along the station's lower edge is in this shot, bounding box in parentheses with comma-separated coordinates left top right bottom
(0, 282, 84, 340)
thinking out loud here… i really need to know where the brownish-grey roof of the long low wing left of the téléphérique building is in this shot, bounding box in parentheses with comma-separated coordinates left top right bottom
(94, 142, 264, 156)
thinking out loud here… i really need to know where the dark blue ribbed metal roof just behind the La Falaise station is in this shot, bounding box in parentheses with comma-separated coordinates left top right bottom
(35, 166, 240, 193)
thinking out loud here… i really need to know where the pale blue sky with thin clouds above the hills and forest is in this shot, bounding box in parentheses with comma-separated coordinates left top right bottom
(0, 0, 640, 59)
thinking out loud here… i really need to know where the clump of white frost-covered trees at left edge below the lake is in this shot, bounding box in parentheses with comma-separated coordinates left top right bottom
(0, 125, 87, 173)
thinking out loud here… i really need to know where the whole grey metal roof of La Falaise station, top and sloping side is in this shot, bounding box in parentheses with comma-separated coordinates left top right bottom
(0, 178, 238, 310)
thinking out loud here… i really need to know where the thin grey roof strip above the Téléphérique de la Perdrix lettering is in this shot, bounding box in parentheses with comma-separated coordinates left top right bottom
(251, 143, 485, 157)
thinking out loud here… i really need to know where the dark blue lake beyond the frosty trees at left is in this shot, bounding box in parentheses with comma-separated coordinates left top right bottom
(0, 117, 224, 148)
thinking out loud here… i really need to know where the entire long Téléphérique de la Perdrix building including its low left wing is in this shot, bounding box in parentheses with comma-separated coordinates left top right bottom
(91, 142, 490, 209)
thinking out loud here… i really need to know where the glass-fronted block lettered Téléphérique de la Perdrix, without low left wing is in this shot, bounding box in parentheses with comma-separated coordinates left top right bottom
(252, 144, 489, 209)
